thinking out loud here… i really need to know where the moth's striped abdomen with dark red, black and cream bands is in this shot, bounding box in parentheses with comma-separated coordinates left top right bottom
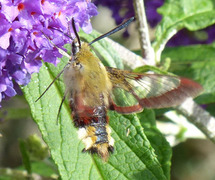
(70, 100, 114, 161)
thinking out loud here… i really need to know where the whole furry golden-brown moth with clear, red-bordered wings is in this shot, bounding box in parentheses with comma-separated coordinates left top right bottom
(38, 18, 202, 161)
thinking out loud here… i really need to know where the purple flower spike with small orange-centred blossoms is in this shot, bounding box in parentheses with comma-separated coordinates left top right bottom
(0, 0, 97, 107)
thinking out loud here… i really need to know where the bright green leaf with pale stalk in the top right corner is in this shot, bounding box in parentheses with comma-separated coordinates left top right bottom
(153, 0, 215, 61)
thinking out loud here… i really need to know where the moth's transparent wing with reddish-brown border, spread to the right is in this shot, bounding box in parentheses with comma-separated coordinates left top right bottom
(106, 67, 203, 113)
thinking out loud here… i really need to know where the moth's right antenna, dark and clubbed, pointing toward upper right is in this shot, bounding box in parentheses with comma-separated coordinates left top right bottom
(89, 17, 135, 45)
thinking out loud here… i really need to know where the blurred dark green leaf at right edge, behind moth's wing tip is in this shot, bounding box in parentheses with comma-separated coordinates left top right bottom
(162, 44, 215, 104)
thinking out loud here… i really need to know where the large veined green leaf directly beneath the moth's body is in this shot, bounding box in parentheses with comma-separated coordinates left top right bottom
(23, 31, 171, 180)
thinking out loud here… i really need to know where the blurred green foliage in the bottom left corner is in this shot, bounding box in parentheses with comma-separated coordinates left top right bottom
(0, 135, 58, 180)
